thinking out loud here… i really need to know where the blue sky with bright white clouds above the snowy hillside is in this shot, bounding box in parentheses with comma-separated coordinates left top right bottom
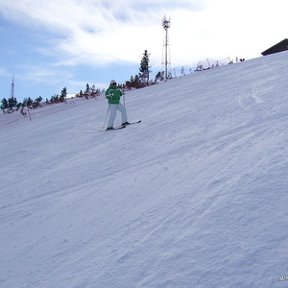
(0, 0, 287, 100)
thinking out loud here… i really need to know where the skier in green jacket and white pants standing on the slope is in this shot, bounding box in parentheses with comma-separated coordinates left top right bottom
(105, 80, 129, 130)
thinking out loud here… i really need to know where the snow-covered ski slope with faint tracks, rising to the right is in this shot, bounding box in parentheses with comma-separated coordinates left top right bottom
(0, 52, 288, 288)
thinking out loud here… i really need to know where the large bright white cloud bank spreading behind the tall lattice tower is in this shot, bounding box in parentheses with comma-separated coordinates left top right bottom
(0, 0, 286, 79)
